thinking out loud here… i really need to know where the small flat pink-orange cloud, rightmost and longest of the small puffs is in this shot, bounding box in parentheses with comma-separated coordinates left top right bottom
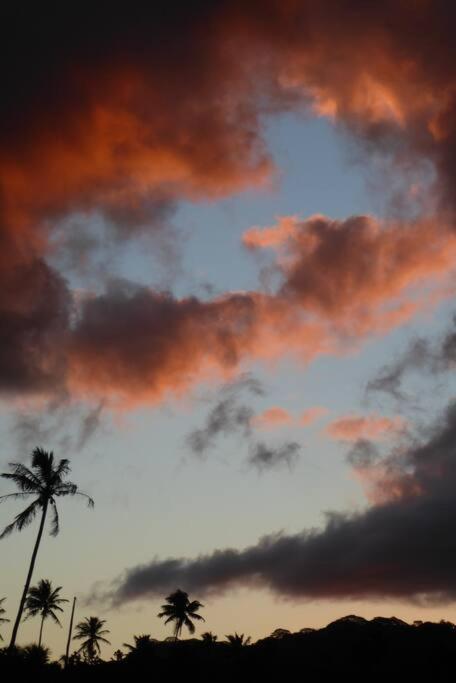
(326, 415, 406, 441)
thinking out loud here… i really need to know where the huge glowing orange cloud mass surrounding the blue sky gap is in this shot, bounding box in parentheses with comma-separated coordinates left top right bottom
(4, 0, 456, 404)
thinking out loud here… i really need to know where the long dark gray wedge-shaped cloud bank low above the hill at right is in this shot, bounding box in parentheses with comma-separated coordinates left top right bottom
(97, 405, 456, 604)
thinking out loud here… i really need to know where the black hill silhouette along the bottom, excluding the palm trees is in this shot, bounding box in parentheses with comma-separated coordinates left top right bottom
(0, 615, 456, 683)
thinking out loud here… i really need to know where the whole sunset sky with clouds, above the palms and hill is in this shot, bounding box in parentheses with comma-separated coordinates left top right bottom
(0, 0, 456, 657)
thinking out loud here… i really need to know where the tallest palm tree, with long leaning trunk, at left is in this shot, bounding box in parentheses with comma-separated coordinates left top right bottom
(0, 448, 94, 650)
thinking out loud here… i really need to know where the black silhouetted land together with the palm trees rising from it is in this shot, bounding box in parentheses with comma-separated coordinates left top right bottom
(0, 448, 456, 683)
